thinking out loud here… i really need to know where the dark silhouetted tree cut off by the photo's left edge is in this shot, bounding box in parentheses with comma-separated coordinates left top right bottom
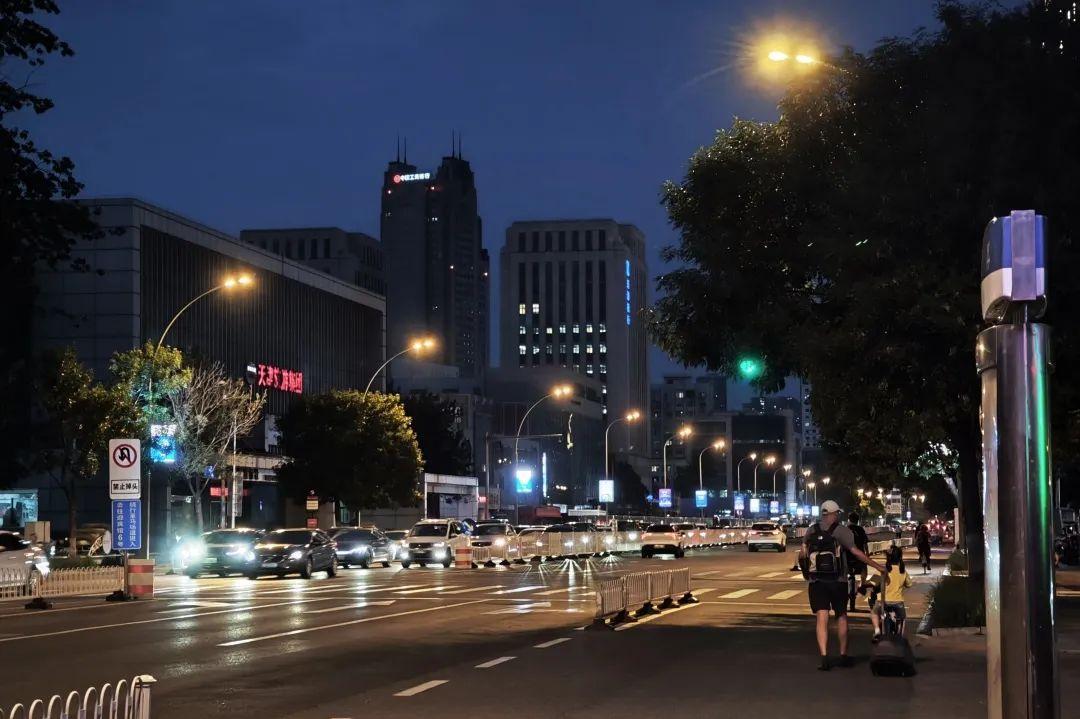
(0, 0, 102, 477)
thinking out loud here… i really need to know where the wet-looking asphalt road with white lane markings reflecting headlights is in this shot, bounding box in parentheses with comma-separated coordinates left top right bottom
(0, 547, 1064, 719)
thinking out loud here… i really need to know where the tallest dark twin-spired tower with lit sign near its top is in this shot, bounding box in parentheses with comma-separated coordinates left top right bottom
(380, 142, 489, 383)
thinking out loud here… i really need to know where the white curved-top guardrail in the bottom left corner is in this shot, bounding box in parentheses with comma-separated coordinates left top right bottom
(0, 675, 156, 719)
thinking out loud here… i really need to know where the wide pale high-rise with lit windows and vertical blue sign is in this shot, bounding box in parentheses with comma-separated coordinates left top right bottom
(499, 219, 649, 474)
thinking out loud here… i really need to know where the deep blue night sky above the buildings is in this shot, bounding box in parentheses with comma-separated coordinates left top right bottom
(16, 0, 935, 386)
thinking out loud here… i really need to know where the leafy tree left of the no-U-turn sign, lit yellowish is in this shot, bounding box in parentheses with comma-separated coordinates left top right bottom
(19, 348, 141, 558)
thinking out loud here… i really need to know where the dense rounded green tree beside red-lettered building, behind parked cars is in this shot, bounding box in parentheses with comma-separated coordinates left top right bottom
(278, 390, 423, 510)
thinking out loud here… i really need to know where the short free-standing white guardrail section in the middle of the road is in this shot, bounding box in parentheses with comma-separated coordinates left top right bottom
(592, 567, 698, 628)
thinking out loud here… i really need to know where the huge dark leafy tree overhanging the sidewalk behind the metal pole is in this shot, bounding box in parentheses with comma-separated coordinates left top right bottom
(650, 2, 1080, 573)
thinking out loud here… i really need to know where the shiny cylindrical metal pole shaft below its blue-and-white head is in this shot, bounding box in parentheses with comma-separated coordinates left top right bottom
(975, 315, 1061, 719)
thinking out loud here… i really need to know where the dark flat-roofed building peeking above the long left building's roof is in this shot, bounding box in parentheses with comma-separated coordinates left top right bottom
(240, 227, 387, 295)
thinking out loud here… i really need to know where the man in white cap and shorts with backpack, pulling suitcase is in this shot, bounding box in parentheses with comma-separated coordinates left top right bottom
(799, 500, 885, 671)
